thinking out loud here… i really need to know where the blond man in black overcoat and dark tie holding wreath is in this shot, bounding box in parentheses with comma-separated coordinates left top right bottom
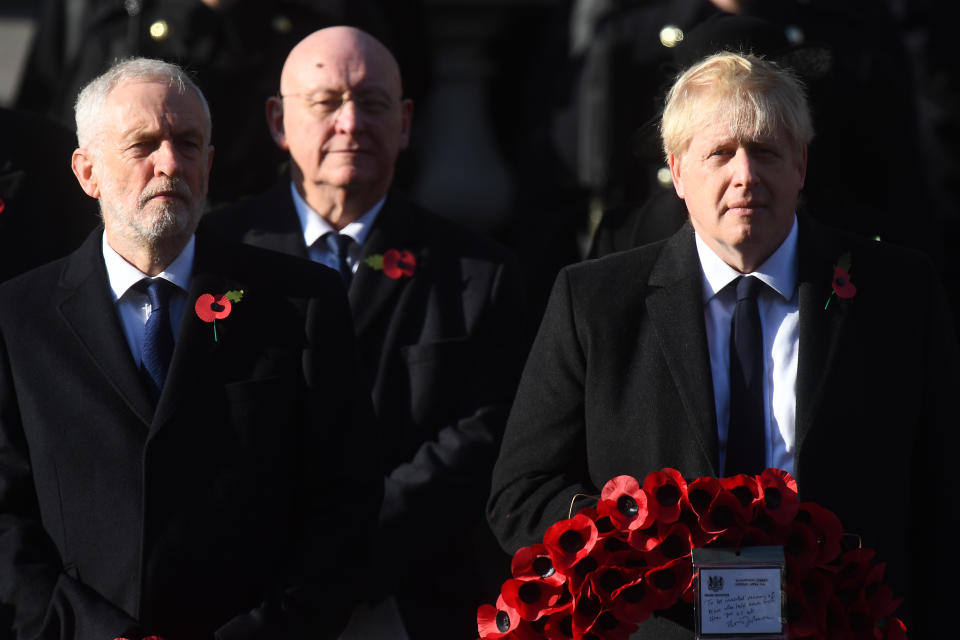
(488, 53, 960, 639)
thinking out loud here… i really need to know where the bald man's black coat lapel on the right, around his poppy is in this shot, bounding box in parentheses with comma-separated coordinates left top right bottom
(349, 196, 418, 336)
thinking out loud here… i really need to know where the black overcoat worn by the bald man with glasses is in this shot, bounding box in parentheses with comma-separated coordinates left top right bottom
(203, 182, 525, 640)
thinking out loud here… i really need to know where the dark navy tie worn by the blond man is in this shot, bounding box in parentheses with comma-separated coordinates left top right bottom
(724, 276, 766, 476)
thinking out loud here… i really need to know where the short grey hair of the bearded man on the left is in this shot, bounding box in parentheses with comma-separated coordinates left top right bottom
(74, 58, 212, 148)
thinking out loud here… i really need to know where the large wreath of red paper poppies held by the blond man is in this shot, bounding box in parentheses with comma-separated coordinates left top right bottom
(477, 469, 907, 640)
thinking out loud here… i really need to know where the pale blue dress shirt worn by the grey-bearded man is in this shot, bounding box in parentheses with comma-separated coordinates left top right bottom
(103, 233, 196, 367)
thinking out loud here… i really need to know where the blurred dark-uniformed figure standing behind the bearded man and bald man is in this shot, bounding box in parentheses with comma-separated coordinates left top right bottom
(16, 0, 419, 204)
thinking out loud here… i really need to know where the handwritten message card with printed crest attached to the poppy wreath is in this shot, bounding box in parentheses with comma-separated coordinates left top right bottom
(700, 567, 783, 636)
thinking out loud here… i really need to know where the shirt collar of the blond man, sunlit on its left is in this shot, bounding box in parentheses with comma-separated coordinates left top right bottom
(694, 216, 798, 302)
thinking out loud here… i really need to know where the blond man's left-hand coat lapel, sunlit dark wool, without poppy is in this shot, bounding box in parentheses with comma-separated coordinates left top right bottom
(646, 224, 719, 473)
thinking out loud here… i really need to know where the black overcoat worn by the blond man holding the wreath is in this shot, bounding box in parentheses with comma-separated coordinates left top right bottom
(488, 219, 960, 638)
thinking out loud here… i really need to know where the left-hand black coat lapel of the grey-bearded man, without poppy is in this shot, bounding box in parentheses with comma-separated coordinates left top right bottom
(59, 227, 153, 425)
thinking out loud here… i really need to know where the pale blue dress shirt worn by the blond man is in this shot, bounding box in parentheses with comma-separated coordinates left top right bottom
(696, 217, 800, 474)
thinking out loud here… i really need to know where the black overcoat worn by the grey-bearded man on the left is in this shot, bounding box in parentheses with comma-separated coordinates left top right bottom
(0, 231, 382, 640)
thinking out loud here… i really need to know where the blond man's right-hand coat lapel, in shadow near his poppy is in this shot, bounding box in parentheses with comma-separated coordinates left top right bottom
(796, 217, 855, 462)
